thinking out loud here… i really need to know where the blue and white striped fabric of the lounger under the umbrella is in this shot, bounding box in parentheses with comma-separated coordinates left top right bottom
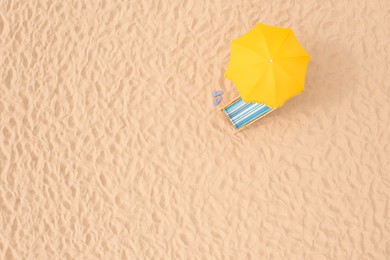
(223, 98, 272, 129)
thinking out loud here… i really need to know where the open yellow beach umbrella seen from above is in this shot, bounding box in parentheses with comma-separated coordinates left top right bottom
(225, 24, 310, 108)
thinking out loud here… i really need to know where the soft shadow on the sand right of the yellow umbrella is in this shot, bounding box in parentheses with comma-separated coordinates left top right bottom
(269, 40, 358, 117)
